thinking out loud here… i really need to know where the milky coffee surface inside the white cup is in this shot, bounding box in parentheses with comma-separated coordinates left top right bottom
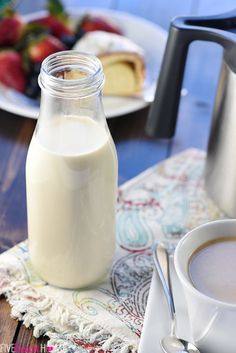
(189, 236, 236, 304)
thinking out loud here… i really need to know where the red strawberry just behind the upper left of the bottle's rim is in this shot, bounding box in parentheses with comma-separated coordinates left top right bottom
(28, 35, 66, 63)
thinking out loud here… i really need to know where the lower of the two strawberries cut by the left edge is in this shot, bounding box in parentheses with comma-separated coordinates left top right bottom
(0, 50, 26, 93)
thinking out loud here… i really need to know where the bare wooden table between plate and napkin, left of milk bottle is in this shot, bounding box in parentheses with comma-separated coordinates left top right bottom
(0, 111, 35, 252)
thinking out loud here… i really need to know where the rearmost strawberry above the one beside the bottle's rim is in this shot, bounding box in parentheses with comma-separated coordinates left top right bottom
(31, 15, 74, 39)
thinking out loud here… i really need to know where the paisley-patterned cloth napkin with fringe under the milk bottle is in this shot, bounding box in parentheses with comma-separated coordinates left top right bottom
(0, 149, 224, 353)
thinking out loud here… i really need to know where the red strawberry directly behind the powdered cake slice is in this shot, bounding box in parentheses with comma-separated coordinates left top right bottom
(79, 15, 122, 35)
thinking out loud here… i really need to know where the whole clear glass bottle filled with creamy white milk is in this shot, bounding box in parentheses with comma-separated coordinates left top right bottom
(26, 51, 117, 288)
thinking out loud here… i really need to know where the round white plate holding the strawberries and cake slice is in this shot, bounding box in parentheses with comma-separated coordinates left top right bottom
(0, 8, 167, 119)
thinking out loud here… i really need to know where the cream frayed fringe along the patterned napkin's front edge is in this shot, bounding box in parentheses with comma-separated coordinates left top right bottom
(0, 264, 137, 353)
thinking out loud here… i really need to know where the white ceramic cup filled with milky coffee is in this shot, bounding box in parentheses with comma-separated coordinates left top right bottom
(174, 219, 236, 353)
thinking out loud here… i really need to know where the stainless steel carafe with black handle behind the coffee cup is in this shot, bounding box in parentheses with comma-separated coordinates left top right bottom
(146, 9, 236, 217)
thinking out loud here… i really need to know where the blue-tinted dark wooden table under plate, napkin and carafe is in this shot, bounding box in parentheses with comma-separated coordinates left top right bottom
(0, 0, 234, 347)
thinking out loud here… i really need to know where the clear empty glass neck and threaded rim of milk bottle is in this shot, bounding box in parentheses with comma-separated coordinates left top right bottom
(36, 51, 106, 125)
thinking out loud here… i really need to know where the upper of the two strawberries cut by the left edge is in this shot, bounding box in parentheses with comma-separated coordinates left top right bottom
(0, 14, 24, 45)
